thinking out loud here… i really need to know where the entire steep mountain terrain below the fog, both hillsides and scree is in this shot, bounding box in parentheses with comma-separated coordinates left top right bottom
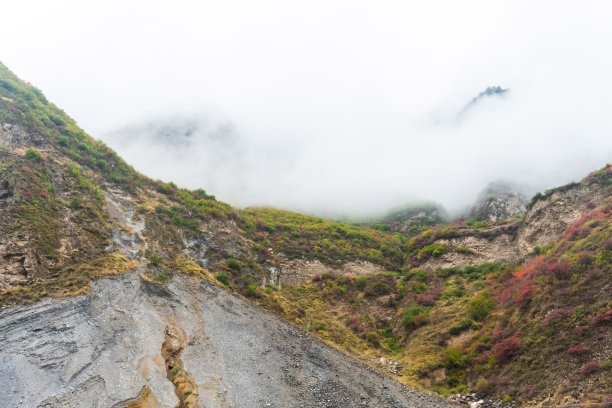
(0, 61, 612, 407)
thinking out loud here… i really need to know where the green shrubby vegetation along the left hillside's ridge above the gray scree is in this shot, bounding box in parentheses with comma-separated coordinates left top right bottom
(0, 63, 416, 300)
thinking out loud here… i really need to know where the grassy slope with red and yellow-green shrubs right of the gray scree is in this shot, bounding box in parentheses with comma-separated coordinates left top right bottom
(251, 166, 612, 403)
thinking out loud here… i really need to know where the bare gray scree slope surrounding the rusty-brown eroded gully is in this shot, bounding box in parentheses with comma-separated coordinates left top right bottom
(0, 272, 453, 408)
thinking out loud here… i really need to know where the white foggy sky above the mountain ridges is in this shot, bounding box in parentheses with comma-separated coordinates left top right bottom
(0, 0, 612, 214)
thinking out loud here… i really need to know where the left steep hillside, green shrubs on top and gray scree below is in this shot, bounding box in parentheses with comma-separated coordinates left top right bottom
(0, 65, 460, 407)
